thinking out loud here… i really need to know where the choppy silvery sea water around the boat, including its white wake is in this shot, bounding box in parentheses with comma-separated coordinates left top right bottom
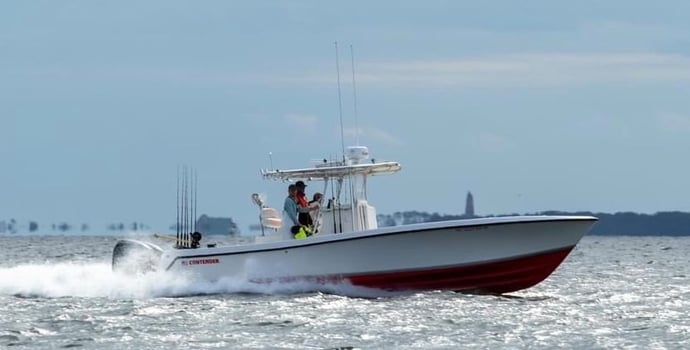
(0, 236, 690, 350)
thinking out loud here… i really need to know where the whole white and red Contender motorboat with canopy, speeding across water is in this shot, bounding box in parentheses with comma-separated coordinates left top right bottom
(113, 146, 597, 294)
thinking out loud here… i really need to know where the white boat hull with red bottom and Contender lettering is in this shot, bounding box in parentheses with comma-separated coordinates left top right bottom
(149, 217, 596, 293)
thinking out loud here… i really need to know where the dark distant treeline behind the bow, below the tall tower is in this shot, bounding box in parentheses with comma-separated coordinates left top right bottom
(377, 211, 690, 236)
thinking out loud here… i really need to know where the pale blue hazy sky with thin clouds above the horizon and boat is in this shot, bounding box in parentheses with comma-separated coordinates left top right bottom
(0, 0, 690, 231)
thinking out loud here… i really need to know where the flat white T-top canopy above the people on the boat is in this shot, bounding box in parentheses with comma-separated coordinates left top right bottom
(261, 162, 401, 181)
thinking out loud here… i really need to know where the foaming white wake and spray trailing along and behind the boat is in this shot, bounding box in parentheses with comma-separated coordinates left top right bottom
(0, 262, 400, 299)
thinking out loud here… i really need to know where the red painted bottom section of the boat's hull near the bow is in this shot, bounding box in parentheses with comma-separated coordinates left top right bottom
(346, 247, 574, 294)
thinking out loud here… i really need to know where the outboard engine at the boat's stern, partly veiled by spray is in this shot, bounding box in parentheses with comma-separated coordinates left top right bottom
(113, 239, 163, 274)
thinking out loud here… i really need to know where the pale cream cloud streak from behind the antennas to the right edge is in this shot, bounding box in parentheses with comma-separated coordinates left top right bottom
(262, 52, 690, 88)
